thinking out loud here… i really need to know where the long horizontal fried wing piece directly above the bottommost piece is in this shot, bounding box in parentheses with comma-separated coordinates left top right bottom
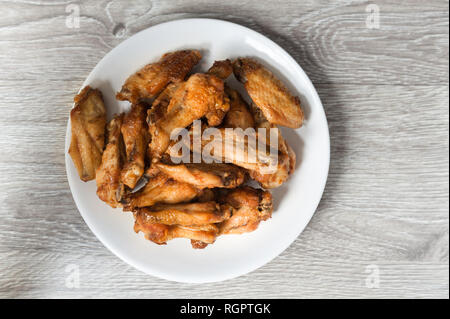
(130, 202, 231, 226)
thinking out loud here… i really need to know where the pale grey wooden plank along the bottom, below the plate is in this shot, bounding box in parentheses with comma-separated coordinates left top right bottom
(0, 252, 448, 299)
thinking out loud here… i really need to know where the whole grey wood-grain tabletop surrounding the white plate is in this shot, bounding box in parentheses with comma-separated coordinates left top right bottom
(0, 0, 449, 298)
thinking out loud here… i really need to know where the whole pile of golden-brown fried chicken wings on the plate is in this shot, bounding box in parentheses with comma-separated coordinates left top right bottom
(69, 50, 304, 248)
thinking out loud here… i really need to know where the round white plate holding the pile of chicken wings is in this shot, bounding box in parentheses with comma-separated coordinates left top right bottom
(65, 19, 330, 283)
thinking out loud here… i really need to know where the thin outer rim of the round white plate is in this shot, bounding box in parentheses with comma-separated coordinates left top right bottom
(64, 18, 331, 284)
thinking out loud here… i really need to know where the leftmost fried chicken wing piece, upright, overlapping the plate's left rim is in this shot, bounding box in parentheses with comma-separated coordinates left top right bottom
(69, 86, 106, 182)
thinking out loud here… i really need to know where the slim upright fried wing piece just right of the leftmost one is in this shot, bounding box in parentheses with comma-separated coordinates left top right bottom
(95, 114, 125, 208)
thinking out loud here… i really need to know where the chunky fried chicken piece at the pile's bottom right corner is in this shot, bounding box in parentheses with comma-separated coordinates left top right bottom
(219, 186, 273, 234)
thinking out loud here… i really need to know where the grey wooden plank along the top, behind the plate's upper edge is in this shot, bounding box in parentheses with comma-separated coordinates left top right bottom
(0, 0, 449, 85)
